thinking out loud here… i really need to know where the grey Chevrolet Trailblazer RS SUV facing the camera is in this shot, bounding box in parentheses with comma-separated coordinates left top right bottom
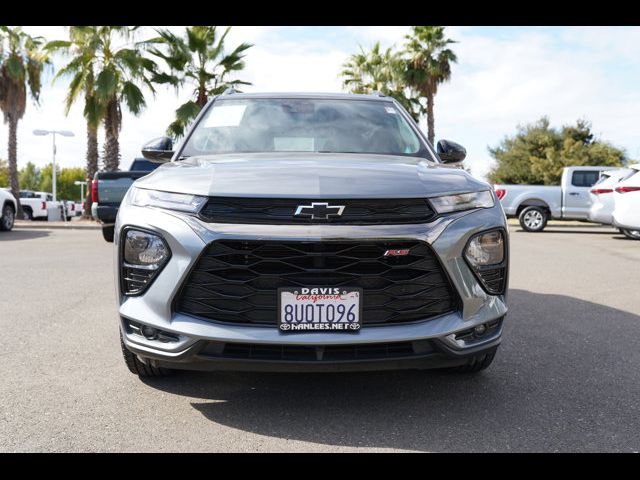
(115, 92, 508, 376)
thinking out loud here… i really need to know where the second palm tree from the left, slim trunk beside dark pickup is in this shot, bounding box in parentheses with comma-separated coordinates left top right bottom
(45, 26, 105, 218)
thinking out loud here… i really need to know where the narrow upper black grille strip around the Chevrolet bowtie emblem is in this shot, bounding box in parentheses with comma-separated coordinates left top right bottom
(200, 197, 436, 225)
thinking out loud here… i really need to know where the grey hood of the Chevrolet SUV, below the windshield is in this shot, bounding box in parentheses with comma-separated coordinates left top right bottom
(135, 152, 490, 199)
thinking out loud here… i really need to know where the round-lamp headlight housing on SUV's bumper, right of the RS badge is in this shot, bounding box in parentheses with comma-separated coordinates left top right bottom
(464, 229, 507, 295)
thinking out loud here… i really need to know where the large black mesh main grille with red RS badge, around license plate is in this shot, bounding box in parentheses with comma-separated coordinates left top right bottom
(175, 240, 456, 325)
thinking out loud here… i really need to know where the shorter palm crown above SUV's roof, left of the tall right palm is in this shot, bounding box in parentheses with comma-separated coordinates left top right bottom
(340, 42, 423, 122)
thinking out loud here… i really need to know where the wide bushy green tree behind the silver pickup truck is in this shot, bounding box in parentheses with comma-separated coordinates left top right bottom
(489, 117, 628, 185)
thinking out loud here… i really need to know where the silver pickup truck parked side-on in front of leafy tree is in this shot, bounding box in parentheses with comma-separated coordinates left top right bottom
(494, 167, 614, 232)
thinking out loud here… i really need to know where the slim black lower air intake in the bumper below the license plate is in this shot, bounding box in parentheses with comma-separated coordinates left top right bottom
(199, 340, 434, 362)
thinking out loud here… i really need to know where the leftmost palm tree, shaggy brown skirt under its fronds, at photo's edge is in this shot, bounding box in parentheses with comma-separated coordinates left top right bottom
(0, 26, 48, 218)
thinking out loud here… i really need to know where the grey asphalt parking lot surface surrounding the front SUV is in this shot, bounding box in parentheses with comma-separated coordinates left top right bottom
(0, 223, 640, 452)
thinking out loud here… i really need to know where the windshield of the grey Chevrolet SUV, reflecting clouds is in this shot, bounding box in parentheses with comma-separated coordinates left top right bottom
(181, 98, 428, 156)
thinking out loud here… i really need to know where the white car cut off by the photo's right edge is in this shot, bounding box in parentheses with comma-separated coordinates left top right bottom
(613, 164, 640, 240)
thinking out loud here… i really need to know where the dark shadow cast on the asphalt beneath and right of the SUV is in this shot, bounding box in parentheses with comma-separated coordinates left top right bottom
(140, 290, 640, 452)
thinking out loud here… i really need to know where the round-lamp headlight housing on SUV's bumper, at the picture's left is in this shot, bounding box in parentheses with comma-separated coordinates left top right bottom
(120, 228, 171, 295)
